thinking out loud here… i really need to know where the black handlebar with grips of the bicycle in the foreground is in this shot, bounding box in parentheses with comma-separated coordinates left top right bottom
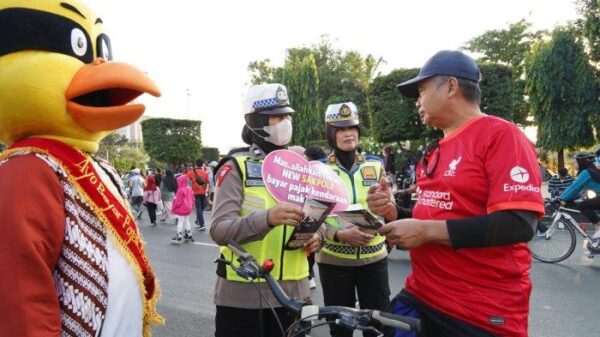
(220, 240, 421, 332)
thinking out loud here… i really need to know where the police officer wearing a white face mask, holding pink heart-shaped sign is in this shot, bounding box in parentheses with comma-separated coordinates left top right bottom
(210, 84, 321, 337)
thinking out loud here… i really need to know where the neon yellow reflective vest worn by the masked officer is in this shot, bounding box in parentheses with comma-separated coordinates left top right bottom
(221, 156, 308, 282)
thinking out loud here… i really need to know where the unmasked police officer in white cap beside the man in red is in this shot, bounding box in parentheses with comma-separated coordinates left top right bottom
(317, 102, 393, 337)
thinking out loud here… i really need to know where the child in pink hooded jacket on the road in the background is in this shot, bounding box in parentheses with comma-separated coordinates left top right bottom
(171, 175, 194, 244)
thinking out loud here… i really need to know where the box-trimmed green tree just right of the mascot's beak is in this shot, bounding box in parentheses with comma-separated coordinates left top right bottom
(142, 118, 202, 167)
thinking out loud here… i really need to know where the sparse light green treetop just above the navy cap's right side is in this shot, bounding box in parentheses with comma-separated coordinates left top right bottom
(461, 19, 544, 78)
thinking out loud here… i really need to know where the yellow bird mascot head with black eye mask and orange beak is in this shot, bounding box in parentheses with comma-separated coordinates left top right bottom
(0, 0, 160, 152)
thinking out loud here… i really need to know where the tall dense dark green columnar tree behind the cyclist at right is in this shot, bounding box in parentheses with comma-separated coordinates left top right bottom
(526, 27, 599, 167)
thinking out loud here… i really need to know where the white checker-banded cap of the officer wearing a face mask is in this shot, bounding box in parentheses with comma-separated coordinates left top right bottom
(242, 83, 295, 115)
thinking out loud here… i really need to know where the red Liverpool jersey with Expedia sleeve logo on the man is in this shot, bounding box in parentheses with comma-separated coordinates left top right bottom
(406, 116, 544, 337)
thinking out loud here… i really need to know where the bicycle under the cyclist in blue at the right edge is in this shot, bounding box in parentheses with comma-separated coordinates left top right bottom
(529, 199, 600, 263)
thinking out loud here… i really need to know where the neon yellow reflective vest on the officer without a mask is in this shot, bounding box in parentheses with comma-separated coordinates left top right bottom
(322, 161, 387, 259)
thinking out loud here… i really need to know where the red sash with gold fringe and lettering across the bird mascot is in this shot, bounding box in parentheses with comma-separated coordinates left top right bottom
(7, 138, 164, 336)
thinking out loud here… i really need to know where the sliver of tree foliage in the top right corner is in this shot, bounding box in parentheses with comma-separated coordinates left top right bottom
(577, 0, 600, 62)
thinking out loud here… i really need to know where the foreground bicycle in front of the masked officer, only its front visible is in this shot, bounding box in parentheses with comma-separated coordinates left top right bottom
(215, 240, 421, 337)
